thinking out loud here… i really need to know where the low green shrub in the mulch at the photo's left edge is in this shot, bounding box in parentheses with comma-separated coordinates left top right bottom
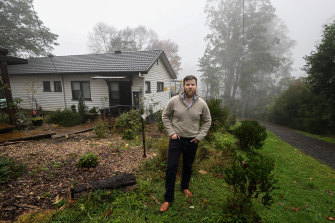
(0, 156, 26, 184)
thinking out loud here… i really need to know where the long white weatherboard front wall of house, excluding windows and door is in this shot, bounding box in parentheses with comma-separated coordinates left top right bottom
(10, 74, 109, 111)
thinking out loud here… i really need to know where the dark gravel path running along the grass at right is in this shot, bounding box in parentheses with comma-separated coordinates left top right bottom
(262, 123, 335, 169)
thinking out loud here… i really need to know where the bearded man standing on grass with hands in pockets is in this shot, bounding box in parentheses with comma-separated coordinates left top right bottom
(159, 75, 212, 212)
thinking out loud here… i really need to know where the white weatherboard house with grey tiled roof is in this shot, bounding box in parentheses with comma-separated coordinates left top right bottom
(8, 50, 176, 111)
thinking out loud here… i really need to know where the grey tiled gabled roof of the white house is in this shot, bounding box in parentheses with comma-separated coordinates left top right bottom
(8, 50, 176, 78)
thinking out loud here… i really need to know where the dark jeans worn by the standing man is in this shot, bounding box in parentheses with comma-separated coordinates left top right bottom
(164, 138, 198, 202)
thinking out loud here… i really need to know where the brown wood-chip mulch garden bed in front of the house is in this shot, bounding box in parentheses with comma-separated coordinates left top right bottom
(0, 129, 159, 220)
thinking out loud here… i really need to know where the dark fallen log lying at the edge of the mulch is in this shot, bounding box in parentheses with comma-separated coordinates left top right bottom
(71, 174, 136, 199)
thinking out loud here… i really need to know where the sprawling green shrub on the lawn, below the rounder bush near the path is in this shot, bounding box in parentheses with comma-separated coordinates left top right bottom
(224, 152, 277, 205)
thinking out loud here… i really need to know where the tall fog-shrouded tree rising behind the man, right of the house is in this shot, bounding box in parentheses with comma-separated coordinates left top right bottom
(199, 0, 294, 116)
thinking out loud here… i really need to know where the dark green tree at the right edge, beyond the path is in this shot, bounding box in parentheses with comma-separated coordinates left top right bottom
(304, 21, 335, 107)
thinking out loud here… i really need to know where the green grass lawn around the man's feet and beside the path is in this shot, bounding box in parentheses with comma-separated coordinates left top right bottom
(21, 133, 335, 222)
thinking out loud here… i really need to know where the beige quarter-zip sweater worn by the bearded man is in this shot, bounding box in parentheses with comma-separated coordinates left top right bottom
(162, 95, 212, 141)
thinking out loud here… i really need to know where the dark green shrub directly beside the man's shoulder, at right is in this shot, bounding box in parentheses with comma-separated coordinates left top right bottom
(207, 98, 229, 132)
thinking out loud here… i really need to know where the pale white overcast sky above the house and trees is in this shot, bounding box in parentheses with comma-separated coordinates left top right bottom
(34, 0, 335, 78)
